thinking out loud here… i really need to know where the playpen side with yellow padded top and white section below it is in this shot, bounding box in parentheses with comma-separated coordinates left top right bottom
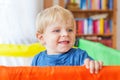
(0, 43, 45, 66)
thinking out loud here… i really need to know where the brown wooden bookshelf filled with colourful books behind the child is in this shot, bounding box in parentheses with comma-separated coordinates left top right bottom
(44, 0, 117, 48)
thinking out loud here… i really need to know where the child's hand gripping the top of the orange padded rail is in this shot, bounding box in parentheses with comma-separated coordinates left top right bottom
(84, 59, 103, 74)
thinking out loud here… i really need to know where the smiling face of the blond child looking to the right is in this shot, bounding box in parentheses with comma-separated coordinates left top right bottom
(37, 20, 75, 54)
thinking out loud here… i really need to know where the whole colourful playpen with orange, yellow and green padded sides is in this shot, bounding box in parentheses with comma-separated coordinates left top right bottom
(0, 39, 120, 80)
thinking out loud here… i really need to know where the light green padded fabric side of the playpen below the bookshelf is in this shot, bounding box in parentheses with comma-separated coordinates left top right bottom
(78, 39, 120, 65)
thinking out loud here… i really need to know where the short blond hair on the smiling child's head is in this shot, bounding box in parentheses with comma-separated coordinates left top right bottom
(36, 5, 75, 33)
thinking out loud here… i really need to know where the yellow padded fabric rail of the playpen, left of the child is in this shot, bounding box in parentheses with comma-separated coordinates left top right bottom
(0, 43, 45, 57)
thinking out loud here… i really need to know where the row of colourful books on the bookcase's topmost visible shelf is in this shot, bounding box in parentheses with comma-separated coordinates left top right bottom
(72, 0, 113, 10)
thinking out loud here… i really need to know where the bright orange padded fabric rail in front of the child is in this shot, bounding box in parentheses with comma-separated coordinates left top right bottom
(0, 66, 120, 80)
